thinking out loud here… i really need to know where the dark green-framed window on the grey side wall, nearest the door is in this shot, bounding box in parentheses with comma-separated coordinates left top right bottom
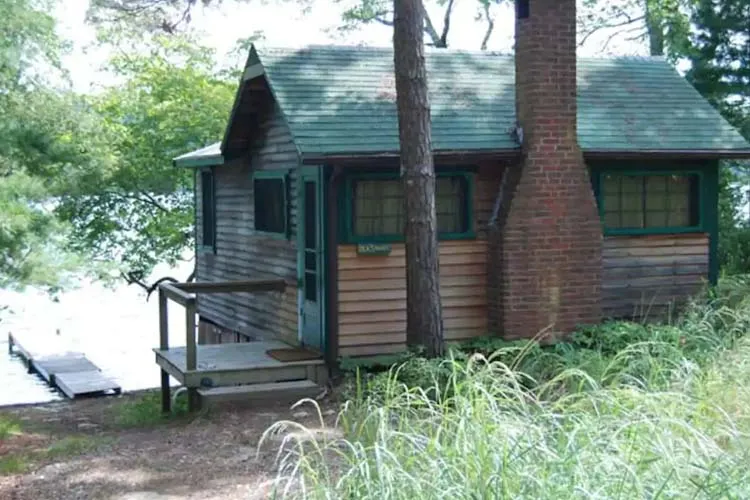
(253, 171, 287, 237)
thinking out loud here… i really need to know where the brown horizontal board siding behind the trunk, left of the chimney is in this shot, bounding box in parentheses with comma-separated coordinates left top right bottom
(338, 240, 487, 356)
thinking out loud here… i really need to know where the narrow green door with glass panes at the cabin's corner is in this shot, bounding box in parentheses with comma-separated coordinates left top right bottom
(297, 167, 325, 352)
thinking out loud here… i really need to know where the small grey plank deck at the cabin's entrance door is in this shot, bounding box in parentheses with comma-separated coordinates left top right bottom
(154, 340, 325, 387)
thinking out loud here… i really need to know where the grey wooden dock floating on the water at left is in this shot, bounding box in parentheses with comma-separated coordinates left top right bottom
(8, 333, 122, 399)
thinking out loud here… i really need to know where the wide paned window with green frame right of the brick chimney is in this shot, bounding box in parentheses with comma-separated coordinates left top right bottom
(599, 172, 701, 232)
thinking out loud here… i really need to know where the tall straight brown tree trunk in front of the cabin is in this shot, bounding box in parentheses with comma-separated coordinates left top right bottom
(393, 0, 445, 356)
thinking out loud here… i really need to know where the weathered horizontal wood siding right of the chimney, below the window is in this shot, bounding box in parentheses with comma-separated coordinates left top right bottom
(602, 234, 709, 318)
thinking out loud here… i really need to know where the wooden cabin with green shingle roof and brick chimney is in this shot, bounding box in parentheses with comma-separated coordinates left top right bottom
(166, 1, 750, 406)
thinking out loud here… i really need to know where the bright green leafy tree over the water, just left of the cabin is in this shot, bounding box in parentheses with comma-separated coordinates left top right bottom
(56, 35, 234, 281)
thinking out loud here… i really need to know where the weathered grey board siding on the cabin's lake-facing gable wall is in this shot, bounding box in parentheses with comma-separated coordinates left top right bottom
(196, 100, 298, 343)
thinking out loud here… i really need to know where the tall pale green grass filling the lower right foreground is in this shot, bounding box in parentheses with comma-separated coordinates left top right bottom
(269, 280, 750, 500)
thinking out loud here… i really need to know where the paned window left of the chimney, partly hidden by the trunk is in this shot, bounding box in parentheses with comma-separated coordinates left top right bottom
(347, 173, 474, 242)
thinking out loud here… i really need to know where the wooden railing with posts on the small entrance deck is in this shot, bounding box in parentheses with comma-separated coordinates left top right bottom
(159, 279, 286, 412)
